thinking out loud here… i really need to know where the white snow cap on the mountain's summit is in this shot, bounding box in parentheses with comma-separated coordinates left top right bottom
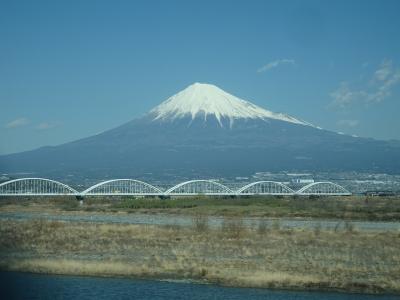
(150, 83, 311, 126)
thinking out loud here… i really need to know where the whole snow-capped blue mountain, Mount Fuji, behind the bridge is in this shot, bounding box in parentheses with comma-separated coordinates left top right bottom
(0, 83, 400, 178)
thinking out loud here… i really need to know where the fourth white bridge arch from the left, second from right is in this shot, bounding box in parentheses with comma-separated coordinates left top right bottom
(237, 181, 295, 195)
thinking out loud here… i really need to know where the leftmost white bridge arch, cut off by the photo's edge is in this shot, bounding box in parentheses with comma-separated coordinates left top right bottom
(0, 178, 79, 196)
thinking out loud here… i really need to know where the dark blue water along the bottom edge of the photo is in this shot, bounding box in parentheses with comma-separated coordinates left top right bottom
(0, 272, 399, 300)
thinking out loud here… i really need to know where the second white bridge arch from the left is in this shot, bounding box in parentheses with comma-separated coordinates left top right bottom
(81, 179, 162, 195)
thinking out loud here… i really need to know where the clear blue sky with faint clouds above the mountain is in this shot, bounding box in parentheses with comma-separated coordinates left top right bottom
(0, 0, 400, 154)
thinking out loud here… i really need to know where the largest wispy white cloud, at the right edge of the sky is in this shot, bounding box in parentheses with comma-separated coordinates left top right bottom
(330, 60, 400, 108)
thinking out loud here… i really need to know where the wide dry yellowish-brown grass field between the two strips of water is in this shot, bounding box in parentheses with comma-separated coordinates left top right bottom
(0, 215, 400, 293)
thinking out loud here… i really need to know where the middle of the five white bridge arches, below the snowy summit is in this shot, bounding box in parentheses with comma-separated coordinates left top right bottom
(165, 179, 234, 195)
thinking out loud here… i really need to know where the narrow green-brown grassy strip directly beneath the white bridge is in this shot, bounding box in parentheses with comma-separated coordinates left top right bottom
(0, 196, 400, 221)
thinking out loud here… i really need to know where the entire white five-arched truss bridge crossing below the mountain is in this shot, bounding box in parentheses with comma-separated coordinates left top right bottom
(0, 178, 351, 196)
